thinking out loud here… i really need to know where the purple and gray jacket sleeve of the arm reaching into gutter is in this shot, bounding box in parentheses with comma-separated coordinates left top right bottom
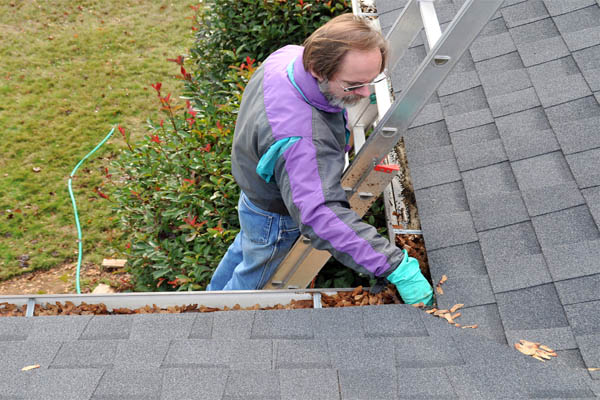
(274, 131, 404, 277)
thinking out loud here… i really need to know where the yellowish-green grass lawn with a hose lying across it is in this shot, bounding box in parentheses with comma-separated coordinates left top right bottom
(0, 0, 193, 280)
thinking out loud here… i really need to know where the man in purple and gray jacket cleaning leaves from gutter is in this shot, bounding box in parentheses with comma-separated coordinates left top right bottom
(207, 14, 433, 304)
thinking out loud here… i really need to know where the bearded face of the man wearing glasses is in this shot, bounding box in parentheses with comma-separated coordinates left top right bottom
(315, 49, 381, 108)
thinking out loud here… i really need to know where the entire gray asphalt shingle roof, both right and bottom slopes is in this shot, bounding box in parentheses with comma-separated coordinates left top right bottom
(0, 0, 600, 400)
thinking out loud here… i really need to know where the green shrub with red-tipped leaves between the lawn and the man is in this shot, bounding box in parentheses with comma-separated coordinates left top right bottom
(113, 66, 254, 291)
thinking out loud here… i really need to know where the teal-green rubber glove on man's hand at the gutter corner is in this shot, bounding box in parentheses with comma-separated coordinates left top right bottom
(387, 250, 433, 306)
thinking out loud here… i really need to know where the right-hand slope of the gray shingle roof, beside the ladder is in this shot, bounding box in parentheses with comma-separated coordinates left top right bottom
(377, 0, 600, 387)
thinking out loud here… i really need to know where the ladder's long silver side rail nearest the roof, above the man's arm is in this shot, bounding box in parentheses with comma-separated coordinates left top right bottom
(342, 0, 503, 193)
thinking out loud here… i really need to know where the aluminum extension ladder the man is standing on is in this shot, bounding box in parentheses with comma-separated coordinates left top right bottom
(264, 0, 504, 289)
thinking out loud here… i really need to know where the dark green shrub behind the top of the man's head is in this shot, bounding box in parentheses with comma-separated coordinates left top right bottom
(188, 0, 351, 101)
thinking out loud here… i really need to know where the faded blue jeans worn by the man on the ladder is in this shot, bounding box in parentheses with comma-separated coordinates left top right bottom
(206, 192, 300, 290)
